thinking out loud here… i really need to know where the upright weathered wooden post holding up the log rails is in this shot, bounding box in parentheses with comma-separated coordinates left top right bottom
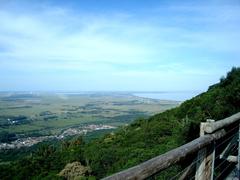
(195, 120, 215, 180)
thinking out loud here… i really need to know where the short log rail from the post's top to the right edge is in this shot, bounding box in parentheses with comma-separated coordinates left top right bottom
(204, 112, 240, 133)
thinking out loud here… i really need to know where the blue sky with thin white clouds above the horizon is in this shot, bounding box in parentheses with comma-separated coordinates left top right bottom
(0, 0, 240, 91)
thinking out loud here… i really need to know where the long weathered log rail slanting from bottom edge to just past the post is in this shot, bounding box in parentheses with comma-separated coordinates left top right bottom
(104, 130, 226, 180)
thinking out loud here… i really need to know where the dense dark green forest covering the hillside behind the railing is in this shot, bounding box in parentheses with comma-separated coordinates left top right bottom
(0, 67, 240, 179)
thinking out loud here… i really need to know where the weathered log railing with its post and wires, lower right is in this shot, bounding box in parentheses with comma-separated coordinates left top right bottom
(104, 112, 240, 180)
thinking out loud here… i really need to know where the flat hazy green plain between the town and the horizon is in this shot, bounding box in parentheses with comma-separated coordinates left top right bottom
(0, 93, 179, 144)
